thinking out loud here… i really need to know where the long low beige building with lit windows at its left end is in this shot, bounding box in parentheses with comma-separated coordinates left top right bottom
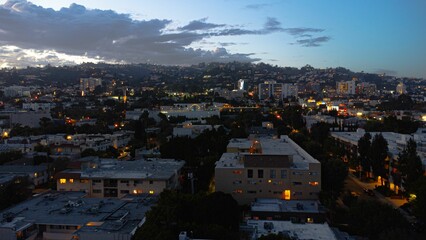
(55, 159, 184, 198)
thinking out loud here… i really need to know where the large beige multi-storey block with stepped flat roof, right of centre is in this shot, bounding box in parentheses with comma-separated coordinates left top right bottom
(215, 136, 321, 204)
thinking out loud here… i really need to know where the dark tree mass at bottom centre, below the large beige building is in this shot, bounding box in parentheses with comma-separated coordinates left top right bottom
(133, 190, 240, 240)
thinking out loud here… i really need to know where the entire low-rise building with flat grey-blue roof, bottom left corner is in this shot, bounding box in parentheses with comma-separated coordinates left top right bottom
(0, 192, 156, 240)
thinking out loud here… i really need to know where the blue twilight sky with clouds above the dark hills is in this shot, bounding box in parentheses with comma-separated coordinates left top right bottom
(0, 0, 426, 78)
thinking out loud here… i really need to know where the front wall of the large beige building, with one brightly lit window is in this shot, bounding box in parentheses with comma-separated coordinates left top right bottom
(215, 163, 321, 204)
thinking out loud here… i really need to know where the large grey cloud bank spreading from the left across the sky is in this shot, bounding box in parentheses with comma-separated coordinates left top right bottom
(0, 0, 329, 67)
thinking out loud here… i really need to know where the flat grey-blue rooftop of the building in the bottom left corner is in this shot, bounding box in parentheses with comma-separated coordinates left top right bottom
(0, 191, 156, 232)
